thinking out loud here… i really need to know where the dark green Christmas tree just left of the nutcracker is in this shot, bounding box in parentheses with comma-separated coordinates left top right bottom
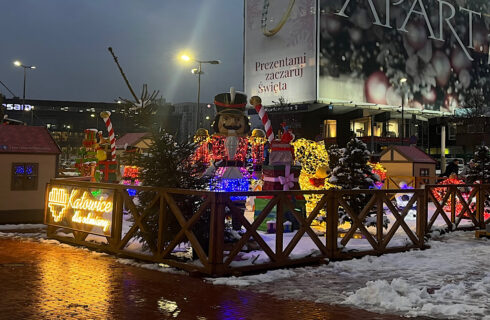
(136, 129, 209, 252)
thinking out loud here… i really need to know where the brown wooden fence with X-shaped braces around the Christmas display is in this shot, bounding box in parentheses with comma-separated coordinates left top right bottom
(45, 179, 489, 275)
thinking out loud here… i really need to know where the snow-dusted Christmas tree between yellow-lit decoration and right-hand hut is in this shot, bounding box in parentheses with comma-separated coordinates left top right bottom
(329, 138, 387, 226)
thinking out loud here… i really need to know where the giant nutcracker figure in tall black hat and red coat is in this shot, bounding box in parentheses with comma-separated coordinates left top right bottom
(210, 88, 250, 230)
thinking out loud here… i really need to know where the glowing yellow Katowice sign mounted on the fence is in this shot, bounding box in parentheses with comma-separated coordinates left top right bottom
(44, 185, 114, 237)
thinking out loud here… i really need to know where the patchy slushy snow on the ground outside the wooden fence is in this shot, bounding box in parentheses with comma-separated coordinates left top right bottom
(207, 232, 490, 320)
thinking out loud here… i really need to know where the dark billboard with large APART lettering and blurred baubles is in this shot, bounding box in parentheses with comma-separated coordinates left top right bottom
(318, 0, 490, 113)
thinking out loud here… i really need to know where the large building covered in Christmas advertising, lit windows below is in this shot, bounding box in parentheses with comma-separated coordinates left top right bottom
(244, 0, 490, 157)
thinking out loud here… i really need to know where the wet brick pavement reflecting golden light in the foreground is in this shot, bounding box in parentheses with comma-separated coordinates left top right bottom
(0, 237, 428, 320)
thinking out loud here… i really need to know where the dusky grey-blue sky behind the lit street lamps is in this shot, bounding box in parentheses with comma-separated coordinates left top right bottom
(0, 0, 243, 103)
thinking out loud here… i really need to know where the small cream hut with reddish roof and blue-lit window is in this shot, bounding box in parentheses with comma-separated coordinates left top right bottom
(0, 125, 61, 223)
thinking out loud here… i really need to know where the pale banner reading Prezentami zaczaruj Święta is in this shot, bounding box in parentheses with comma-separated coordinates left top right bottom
(244, 0, 317, 106)
